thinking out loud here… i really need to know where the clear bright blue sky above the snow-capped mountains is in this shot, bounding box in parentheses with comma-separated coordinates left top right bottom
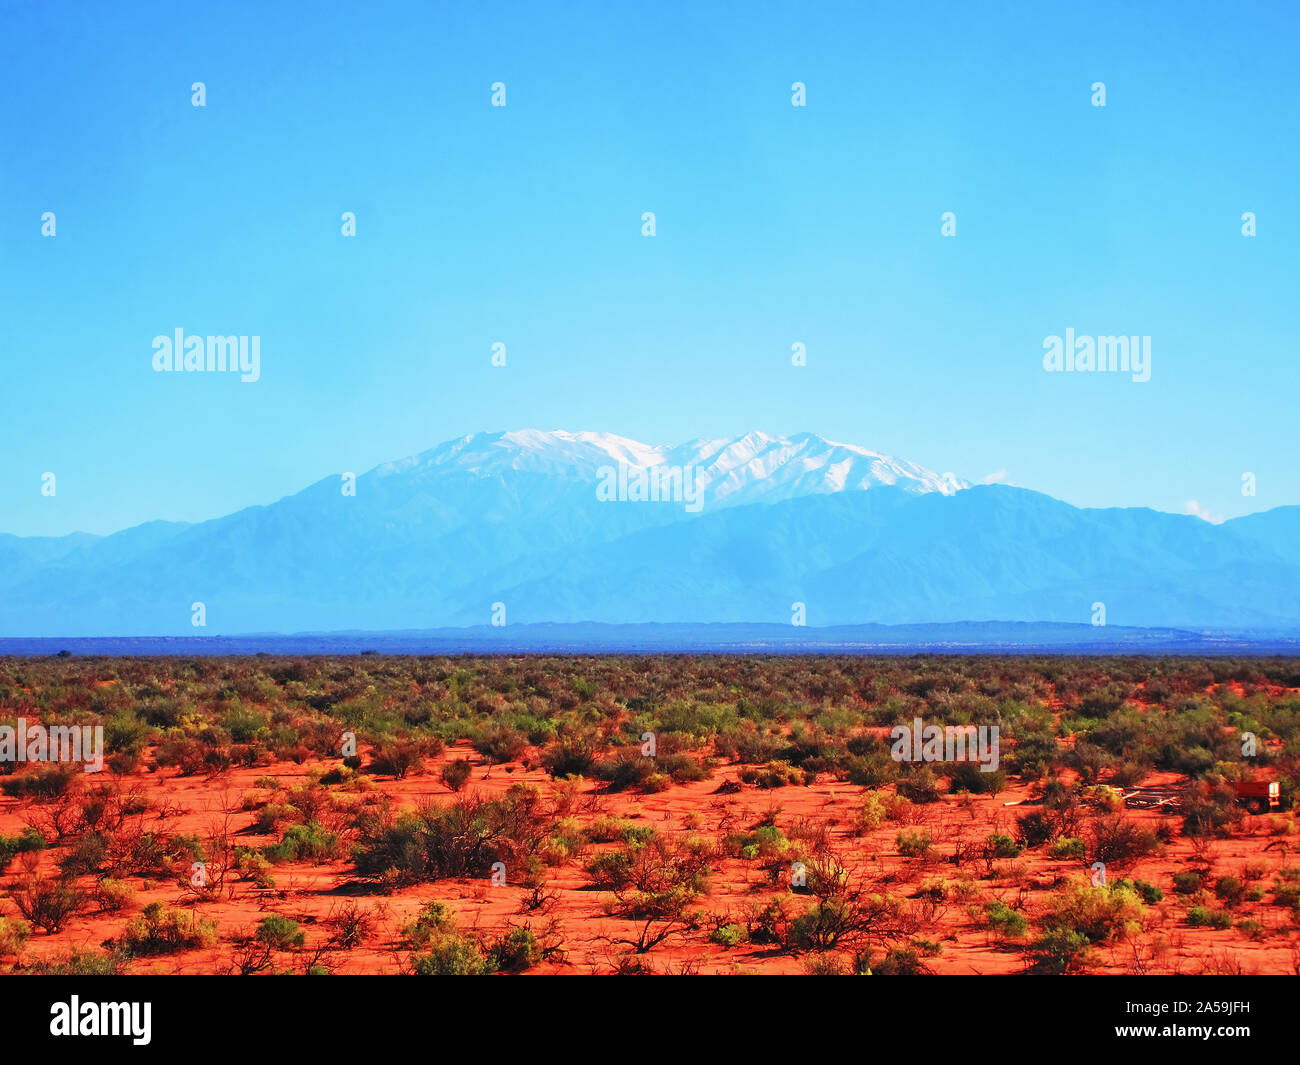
(0, 0, 1300, 534)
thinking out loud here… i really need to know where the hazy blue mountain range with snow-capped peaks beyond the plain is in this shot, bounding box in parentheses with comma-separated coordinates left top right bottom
(0, 429, 1300, 642)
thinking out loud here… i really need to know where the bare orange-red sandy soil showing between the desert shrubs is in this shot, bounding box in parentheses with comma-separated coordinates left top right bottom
(0, 745, 1300, 974)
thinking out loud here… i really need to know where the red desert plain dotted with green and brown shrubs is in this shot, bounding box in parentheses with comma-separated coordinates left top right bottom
(0, 655, 1300, 975)
